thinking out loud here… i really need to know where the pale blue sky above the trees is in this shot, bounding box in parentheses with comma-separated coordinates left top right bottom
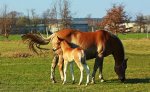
(0, 0, 150, 18)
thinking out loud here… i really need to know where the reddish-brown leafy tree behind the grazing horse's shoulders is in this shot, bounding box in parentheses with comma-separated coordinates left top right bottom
(100, 4, 130, 34)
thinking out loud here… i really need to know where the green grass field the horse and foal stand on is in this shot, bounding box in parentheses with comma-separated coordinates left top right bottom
(0, 34, 150, 92)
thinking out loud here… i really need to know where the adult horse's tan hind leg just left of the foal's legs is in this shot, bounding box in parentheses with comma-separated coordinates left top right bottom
(58, 55, 64, 81)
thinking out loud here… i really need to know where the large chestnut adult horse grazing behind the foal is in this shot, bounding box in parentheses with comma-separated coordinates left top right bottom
(23, 29, 127, 83)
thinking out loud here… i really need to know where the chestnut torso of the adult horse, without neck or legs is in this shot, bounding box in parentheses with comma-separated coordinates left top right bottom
(52, 29, 113, 59)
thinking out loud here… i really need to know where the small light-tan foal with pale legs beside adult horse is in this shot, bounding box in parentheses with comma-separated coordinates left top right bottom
(56, 37, 90, 85)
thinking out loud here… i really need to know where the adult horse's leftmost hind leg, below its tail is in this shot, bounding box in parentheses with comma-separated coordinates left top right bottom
(50, 55, 58, 83)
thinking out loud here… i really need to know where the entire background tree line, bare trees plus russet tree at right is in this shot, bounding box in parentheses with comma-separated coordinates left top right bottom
(0, 0, 148, 38)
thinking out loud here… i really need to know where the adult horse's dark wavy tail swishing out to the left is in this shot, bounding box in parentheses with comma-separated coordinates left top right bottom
(21, 33, 51, 54)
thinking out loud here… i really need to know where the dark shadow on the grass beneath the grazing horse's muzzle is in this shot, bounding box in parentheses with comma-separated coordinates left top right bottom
(106, 78, 150, 84)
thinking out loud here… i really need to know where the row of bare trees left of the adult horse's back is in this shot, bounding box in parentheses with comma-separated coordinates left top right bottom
(0, 0, 72, 38)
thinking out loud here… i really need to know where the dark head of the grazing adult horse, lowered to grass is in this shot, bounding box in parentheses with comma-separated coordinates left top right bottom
(115, 59, 128, 82)
